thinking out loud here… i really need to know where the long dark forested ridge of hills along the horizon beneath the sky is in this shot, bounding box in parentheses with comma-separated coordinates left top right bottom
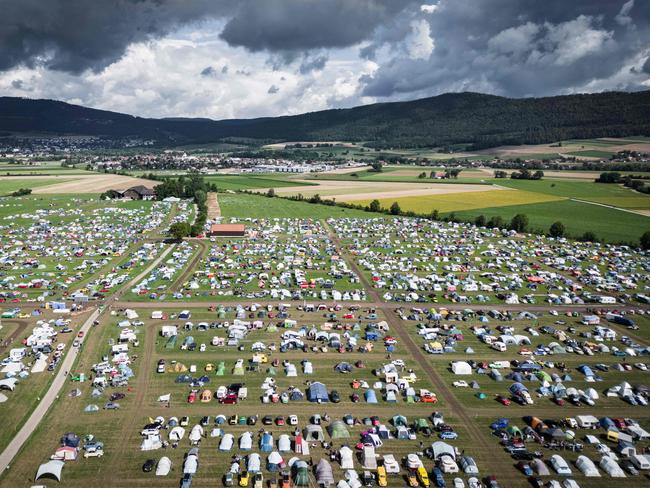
(0, 91, 650, 149)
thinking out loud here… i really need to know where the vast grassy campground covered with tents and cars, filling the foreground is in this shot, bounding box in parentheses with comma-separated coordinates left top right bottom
(0, 188, 650, 487)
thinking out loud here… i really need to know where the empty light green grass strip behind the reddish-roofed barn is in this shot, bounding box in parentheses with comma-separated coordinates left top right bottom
(219, 193, 388, 219)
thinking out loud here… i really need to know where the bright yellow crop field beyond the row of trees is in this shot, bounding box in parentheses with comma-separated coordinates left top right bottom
(351, 190, 566, 213)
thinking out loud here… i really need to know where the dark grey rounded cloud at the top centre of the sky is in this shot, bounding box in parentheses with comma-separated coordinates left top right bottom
(221, 0, 416, 52)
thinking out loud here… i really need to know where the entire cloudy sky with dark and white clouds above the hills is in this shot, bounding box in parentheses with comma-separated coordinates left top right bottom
(0, 0, 650, 119)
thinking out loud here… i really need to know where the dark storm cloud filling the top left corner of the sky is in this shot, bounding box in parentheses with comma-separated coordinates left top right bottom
(0, 0, 230, 73)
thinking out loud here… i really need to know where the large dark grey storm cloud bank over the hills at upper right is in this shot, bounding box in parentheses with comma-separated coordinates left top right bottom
(361, 0, 650, 97)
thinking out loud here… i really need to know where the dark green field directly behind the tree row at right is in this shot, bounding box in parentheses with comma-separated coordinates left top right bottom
(446, 200, 650, 243)
